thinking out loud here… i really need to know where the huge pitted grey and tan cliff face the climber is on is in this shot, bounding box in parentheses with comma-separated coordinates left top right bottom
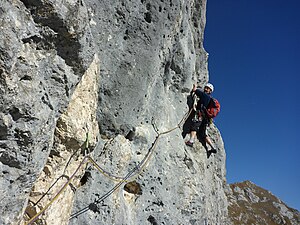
(0, 0, 228, 224)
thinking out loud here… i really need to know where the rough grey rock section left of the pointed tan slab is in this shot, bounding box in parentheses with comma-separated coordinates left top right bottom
(0, 1, 91, 224)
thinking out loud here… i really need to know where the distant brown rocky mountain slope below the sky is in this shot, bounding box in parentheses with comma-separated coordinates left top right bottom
(226, 181, 300, 225)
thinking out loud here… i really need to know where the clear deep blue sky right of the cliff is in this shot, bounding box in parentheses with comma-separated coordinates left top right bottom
(204, 0, 300, 210)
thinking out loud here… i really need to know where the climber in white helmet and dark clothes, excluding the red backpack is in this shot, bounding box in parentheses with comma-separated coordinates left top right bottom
(185, 83, 217, 153)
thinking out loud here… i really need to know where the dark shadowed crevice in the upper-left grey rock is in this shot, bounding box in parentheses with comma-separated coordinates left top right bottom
(22, 0, 85, 74)
